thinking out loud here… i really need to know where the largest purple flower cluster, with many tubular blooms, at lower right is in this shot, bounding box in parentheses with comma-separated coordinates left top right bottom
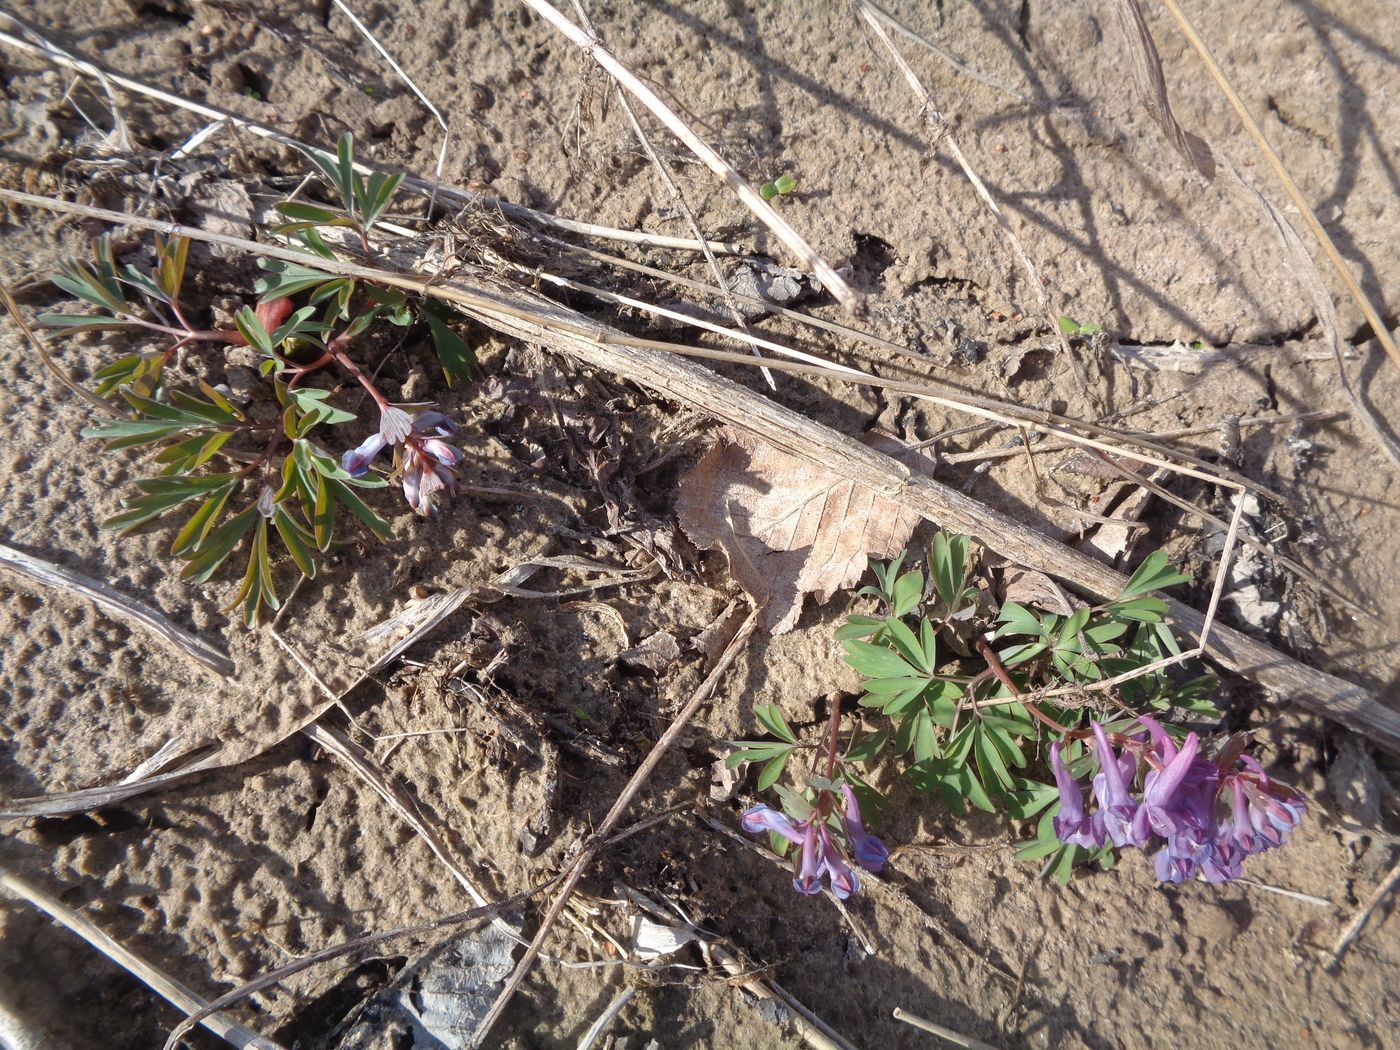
(1050, 715, 1305, 882)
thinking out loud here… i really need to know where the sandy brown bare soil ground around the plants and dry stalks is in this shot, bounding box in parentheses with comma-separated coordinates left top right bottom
(0, 0, 1400, 1047)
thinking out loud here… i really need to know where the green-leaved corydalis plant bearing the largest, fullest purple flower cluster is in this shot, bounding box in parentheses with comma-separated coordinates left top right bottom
(795, 532, 1301, 881)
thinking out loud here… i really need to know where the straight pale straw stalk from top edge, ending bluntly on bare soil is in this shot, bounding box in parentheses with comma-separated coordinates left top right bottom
(521, 0, 858, 309)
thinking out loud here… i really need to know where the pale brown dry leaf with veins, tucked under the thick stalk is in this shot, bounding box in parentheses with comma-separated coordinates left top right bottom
(676, 434, 927, 634)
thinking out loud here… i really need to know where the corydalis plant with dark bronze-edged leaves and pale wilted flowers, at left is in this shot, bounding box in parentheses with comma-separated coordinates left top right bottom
(39, 136, 473, 624)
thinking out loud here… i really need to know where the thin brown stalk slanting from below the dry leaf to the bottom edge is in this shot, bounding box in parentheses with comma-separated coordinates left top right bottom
(472, 609, 759, 1046)
